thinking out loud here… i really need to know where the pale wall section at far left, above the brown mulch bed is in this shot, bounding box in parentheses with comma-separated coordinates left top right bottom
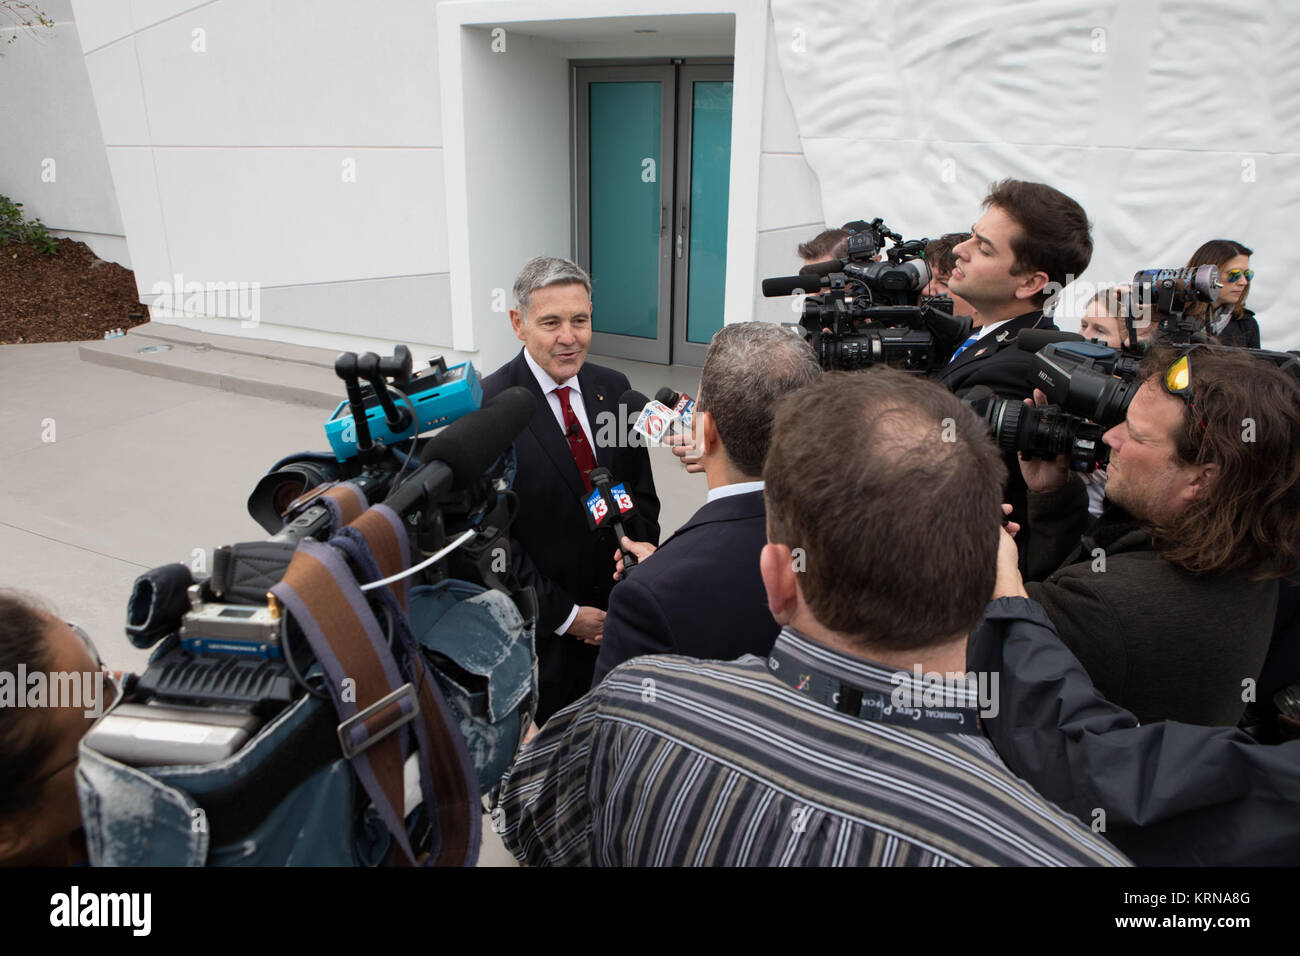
(0, 0, 130, 267)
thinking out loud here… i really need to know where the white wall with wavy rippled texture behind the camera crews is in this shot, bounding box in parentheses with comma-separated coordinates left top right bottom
(771, 0, 1300, 349)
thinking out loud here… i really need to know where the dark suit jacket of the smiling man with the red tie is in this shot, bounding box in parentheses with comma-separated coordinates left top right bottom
(484, 350, 659, 723)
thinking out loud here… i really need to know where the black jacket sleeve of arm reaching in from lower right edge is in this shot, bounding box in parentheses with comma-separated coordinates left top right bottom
(967, 597, 1300, 866)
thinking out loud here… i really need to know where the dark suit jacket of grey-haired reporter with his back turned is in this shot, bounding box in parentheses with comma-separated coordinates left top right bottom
(594, 492, 781, 684)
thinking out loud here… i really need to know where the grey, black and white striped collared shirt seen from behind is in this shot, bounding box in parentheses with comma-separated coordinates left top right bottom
(498, 628, 1127, 866)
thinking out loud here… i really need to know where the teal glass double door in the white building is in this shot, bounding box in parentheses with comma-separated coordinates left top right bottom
(573, 62, 732, 365)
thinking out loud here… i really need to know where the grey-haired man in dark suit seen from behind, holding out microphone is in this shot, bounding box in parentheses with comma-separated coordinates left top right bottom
(594, 321, 822, 683)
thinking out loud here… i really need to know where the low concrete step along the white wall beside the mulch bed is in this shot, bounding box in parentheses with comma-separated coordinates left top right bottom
(78, 323, 343, 410)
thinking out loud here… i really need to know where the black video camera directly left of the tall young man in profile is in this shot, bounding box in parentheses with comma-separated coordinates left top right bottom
(763, 219, 971, 375)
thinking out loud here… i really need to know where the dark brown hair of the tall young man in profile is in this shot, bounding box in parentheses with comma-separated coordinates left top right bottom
(984, 179, 1092, 307)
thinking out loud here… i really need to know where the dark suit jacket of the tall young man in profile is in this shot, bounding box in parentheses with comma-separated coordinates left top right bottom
(939, 311, 1056, 546)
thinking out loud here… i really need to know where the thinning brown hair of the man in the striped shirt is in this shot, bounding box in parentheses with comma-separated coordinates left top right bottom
(763, 368, 1006, 650)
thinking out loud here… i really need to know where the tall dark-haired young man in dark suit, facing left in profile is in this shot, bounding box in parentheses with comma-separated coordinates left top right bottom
(939, 179, 1092, 538)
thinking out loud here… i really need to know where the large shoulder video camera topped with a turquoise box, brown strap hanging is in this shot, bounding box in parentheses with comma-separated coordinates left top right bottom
(83, 346, 537, 868)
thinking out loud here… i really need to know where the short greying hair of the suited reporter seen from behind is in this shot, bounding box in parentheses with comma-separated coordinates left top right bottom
(696, 321, 822, 477)
